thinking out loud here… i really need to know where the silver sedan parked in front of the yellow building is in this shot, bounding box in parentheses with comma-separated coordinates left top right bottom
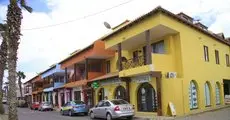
(89, 99, 134, 120)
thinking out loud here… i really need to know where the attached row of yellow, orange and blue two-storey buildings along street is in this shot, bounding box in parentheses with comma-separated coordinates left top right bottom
(24, 7, 230, 116)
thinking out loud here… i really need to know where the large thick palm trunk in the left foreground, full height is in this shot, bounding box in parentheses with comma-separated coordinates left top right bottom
(7, 0, 32, 120)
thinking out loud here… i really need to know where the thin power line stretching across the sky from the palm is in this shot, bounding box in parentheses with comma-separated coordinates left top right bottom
(22, 0, 134, 31)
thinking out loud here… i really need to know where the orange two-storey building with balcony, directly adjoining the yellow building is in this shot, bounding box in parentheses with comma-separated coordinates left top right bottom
(59, 40, 115, 106)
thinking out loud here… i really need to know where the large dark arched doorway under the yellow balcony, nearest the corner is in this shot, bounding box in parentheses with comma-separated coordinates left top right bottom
(137, 83, 157, 112)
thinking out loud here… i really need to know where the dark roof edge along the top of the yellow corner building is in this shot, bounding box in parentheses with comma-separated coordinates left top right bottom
(101, 6, 230, 46)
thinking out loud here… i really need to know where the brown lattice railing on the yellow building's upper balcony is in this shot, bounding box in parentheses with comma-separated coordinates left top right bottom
(122, 56, 145, 70)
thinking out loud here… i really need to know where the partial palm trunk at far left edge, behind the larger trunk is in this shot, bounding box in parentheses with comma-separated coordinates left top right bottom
(0, 23, 7, 114)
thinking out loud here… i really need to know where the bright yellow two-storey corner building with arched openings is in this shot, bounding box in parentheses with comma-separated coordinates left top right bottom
(92, 7, 230, 116)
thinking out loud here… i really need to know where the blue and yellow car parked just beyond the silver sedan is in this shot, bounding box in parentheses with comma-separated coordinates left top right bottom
(60, 100, 89, 116)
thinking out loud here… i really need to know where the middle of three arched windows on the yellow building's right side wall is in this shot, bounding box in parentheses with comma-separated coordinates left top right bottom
(204, 82, 211, 106)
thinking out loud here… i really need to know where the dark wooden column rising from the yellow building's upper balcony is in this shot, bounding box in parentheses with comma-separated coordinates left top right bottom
(145, 30, 152, 65)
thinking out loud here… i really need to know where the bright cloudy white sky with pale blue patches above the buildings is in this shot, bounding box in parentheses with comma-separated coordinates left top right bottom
(0, 0, 230, 82)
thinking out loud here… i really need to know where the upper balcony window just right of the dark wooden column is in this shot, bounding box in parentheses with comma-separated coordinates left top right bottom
(152, 40, 165, 54)
